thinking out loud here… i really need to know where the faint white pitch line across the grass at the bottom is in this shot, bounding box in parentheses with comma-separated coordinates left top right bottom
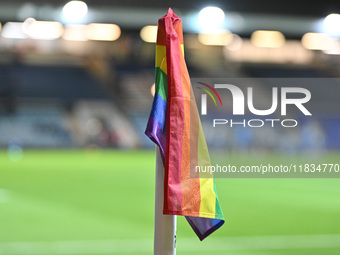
(0, 234, 340, 255)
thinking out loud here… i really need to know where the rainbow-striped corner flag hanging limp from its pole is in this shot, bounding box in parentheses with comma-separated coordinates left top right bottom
(145, 8, 224, 240)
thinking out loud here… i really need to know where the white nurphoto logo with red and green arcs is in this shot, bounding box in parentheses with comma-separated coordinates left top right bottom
(197, 82, 312, 127)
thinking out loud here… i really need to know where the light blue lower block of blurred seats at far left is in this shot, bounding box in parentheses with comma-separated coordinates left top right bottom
(0, 103, 72, 148)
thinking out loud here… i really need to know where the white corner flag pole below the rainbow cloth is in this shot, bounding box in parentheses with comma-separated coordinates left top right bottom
(153, 145, 177, 255)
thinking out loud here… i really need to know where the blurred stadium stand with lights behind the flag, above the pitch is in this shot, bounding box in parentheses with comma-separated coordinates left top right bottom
(0, 0, 340, 152)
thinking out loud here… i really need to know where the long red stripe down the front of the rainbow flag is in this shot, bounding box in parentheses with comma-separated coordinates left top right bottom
(160, 8, 184, 213)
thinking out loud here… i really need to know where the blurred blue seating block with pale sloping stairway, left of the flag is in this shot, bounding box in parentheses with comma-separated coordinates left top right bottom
(0, 57, 139, 148)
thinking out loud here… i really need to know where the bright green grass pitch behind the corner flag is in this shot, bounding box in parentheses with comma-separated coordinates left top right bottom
(0, 150, 340, 255)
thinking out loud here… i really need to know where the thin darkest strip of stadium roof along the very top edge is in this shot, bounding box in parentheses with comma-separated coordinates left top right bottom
(2, 0, 340, 17)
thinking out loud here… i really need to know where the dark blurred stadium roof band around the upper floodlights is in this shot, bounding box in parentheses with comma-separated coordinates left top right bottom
(0, 0, 340, 39)
